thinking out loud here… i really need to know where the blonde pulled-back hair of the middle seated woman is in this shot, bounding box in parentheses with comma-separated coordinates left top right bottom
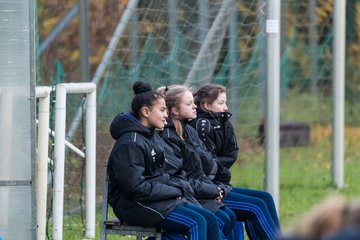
(158, 84, 191, 139)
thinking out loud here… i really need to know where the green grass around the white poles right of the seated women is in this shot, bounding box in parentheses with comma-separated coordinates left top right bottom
(232, 125, 360, 228)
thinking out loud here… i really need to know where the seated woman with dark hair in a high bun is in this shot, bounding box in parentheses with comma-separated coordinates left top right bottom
(108, 82, 225, 240)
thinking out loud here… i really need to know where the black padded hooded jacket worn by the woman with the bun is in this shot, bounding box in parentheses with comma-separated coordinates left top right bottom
(108, 113, 186, 227)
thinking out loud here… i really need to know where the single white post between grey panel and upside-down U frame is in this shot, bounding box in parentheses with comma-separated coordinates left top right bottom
(52, 84, 66, 240)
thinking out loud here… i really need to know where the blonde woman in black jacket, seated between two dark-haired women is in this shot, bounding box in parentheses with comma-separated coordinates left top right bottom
(160, 85, 236, 236)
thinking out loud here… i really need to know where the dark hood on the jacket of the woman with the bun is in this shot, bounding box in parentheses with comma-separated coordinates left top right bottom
(110, 112, 155, 140)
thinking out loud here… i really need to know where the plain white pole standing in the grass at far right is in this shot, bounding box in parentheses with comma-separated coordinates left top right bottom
(332, 0, 346, 188)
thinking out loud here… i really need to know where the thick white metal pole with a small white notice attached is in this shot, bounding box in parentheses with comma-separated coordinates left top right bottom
(265, 0, 281, 209)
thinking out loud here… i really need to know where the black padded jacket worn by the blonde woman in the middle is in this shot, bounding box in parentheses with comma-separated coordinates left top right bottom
(160, 119, 223, 212)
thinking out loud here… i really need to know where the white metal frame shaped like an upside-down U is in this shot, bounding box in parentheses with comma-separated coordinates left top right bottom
(53, 82, 96, 240)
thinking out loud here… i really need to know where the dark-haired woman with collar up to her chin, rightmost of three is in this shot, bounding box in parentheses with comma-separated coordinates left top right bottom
(190, 84, 280, 239)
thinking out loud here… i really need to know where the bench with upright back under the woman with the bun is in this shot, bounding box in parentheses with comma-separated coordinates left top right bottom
(100, 164, 162, 240)
